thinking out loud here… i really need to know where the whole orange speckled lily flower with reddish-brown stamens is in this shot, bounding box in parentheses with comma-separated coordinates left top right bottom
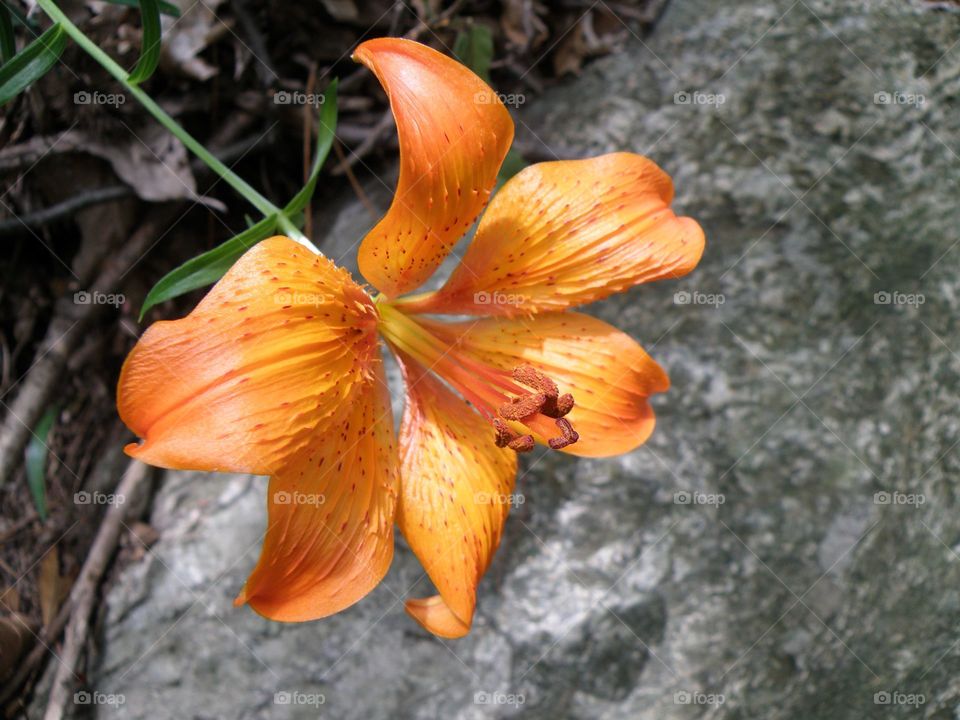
(117, 39, 704, 637)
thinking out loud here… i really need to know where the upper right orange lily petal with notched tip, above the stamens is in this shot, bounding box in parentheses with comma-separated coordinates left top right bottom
(400, 153, 704, 316)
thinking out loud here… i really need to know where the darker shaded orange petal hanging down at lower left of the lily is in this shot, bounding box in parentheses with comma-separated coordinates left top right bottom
(236, 361, 399, 622)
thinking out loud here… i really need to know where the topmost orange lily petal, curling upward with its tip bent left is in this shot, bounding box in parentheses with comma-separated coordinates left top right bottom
(353, 38, 513, 297)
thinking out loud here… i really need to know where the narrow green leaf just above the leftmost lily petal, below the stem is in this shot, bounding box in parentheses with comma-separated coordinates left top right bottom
(140, 215, 277, 320)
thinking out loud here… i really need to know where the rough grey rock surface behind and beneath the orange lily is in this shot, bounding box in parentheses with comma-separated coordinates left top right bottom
(65, 0, 960, 720)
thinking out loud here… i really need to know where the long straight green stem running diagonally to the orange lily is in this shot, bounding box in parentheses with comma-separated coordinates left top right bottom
(37, 0, 317, 252)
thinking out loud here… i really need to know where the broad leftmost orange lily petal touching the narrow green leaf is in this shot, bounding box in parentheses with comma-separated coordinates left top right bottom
(117, 237, 376, 475)
